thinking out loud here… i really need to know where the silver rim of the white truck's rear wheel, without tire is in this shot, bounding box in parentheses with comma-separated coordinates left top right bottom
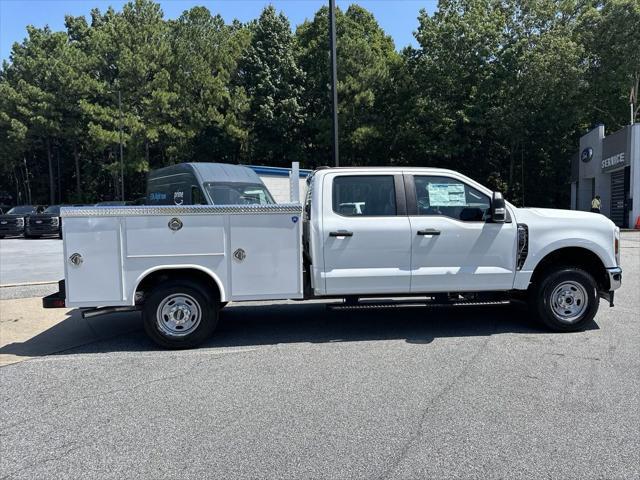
(156, 293, 202, 337)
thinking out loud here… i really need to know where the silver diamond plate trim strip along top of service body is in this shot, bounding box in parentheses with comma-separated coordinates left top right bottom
(60, 203, 302, 218)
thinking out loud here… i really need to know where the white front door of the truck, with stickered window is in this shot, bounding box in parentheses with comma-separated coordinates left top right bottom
(405, 175, 517, 293)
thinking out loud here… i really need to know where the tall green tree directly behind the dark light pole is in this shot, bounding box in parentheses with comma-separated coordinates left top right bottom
(296, 5, 401, 165)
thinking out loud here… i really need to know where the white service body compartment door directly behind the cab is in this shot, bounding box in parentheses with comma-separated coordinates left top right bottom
(229, 214, 302, 300)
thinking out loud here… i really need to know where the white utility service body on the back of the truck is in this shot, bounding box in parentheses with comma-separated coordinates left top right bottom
(61, 204, 303, 308)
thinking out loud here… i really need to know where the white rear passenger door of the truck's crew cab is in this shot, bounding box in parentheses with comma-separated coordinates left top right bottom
(322, 171, 411, 295)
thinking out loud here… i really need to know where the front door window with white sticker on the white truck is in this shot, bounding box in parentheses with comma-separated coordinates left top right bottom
(414, 176, 491, 222)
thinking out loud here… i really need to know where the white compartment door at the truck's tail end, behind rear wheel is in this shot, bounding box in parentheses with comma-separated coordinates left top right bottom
(62, 217, 125, 307)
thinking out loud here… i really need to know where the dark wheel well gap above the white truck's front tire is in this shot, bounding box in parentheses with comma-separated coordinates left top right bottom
(531, 247, 609, 291)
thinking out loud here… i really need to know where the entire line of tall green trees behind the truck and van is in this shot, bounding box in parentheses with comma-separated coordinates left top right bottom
(0, 0, 640, 206)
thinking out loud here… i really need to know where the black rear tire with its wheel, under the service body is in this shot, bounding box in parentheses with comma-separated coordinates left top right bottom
(142, 280, 218, 349)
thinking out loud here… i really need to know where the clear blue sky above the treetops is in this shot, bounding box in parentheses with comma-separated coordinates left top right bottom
(0, 0, 437, 60)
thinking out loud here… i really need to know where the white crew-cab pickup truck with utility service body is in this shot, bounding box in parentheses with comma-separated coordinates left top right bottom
(43, 167, 622, 348)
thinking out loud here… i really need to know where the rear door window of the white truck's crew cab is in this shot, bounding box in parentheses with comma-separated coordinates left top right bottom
(333, 175, 397, 217)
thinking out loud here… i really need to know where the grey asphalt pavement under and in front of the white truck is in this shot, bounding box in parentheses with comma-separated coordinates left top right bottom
(0, 233, 640, 479)
